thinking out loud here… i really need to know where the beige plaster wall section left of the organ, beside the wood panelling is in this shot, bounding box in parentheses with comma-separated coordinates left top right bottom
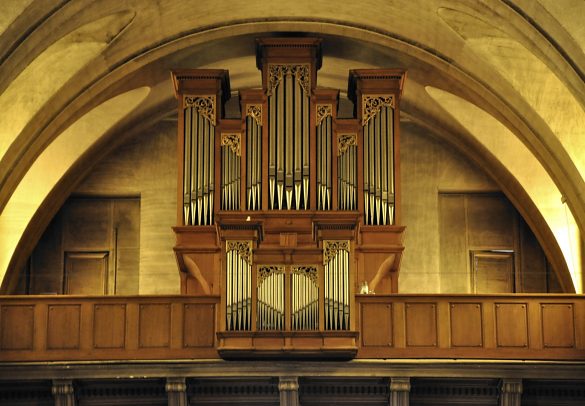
(75, 121, 180, 294)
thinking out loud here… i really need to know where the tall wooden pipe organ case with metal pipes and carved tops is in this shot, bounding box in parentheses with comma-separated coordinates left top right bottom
(172, 38, 406, 359)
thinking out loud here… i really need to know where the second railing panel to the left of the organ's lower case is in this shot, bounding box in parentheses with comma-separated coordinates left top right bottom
(138, 303, 171, 348)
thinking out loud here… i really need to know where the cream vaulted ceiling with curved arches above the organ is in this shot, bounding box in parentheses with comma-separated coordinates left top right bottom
(0, 0, 585, 291)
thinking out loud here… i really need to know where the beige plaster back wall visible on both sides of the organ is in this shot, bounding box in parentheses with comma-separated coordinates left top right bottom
(65, 116, 544, 294)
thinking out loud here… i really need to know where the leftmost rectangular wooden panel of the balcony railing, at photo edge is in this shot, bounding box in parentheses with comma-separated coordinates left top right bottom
(0, 306, 34, 350)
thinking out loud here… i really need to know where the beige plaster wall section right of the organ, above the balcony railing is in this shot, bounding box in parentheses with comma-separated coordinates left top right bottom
(398, 122, 498, 293)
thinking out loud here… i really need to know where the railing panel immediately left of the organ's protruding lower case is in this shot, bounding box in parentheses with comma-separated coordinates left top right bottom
(183, 304, 215, 347)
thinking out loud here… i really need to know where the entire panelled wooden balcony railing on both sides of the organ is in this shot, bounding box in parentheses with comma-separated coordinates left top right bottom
(0, 295, 585, 361)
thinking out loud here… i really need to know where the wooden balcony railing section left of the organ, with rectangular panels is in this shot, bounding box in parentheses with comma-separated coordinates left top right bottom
(0, 296, 219, 361)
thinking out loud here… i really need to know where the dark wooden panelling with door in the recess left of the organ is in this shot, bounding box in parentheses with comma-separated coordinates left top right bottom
(30, 198, 140, 295)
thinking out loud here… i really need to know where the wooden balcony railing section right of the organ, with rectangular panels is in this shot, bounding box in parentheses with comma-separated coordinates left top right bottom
(356, 295, 585, 360)
